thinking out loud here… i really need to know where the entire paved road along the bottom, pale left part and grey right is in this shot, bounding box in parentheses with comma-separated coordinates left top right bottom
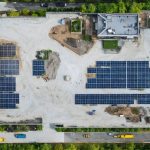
(0, 129, 150, 143)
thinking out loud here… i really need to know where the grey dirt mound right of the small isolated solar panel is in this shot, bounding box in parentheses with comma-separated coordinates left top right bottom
(45, 52, 61, 80)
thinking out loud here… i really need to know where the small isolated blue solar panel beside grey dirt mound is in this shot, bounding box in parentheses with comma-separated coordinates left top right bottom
(32, 60, 45, 76)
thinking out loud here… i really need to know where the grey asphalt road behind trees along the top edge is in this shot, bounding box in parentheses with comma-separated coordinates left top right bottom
(6, 2, 82, 10)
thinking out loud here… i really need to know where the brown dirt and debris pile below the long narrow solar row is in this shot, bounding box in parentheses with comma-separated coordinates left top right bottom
(105, 106, 140, 122)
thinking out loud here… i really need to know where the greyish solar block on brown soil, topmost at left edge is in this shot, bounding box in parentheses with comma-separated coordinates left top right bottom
(0, 44, 16, 57)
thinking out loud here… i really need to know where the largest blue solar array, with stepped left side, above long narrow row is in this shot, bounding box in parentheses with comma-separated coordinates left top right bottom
(86, 61, 150, 89)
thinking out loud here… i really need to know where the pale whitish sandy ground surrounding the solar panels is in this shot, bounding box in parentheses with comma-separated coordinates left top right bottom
(0, 14, 150, 130)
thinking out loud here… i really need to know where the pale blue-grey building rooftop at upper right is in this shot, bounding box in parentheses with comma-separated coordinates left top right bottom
(96, 14, 139, 38)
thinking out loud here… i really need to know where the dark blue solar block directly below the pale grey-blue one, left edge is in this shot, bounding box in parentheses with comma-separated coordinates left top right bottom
(0, 77, 16, 92)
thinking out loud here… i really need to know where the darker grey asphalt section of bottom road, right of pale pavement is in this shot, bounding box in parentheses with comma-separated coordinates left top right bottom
(64, 132, 150, 143)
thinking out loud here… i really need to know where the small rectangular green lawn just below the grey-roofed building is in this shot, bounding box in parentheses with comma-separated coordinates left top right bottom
(102, 40, 118, 49)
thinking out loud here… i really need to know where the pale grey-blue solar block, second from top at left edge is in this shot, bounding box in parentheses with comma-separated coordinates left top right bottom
(0, 59, 19, 76)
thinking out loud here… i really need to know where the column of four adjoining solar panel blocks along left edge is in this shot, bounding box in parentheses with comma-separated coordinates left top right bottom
(0, 44, 19, 109)
